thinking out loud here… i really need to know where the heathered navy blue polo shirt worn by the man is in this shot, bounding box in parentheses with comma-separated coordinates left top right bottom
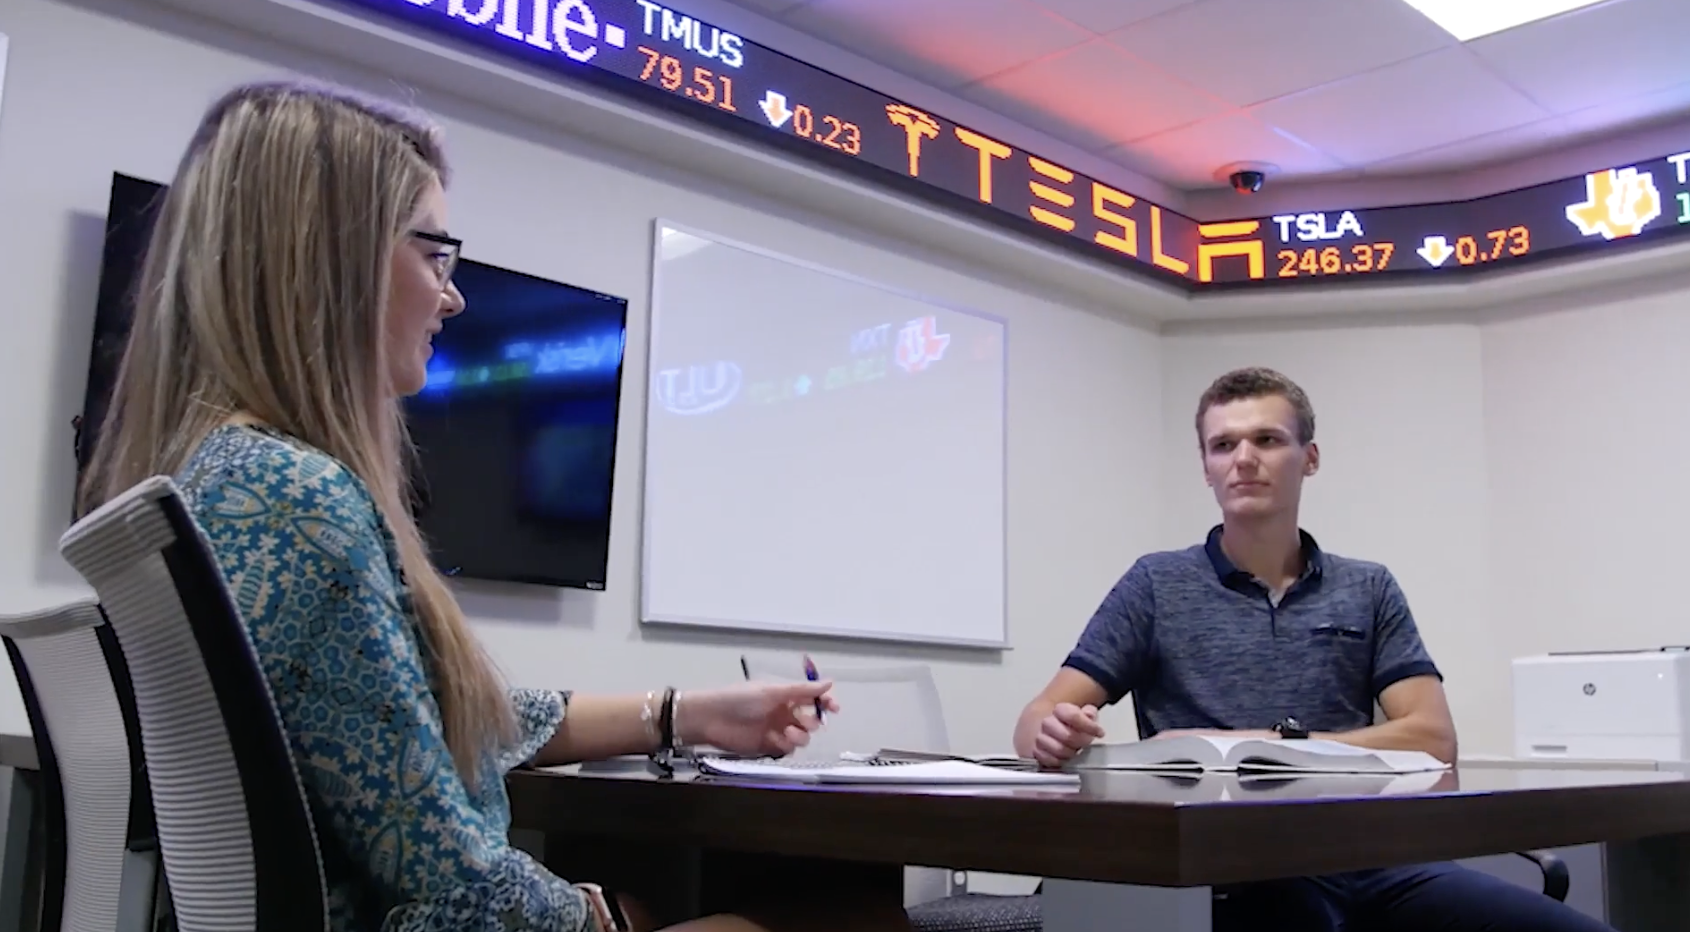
(1065, 526, 1442, 737)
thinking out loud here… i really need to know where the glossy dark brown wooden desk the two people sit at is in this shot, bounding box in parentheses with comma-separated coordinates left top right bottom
(510, 768, 1690, 932)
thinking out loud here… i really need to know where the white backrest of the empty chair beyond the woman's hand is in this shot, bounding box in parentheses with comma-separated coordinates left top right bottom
(742, 656, 951, 759)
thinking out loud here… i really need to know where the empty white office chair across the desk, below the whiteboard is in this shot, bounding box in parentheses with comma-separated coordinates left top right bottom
(740, 656, 1043, 932)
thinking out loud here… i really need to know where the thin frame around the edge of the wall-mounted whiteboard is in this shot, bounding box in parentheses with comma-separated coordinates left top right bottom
(639, 217, 1014, 651)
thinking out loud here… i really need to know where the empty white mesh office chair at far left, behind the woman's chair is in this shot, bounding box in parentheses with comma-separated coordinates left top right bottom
(0, 599, 157, 932)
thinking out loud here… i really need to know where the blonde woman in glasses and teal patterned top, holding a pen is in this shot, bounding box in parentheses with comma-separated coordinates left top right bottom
(79, 83, 902, 932)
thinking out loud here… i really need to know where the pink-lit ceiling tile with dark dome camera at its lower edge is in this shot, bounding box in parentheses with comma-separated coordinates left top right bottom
(1104, 112, 1344, 191)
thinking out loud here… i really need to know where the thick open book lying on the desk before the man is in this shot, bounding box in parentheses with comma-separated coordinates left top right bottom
(1070, 734, 1448, 773)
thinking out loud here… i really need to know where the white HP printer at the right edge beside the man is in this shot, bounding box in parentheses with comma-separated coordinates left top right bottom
(1514, 648, 1690, 761)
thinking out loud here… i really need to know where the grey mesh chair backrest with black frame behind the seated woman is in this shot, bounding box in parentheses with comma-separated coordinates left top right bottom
(59, 475, 328, 932)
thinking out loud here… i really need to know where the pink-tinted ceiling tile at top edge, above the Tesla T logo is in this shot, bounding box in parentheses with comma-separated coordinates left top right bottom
(786, 0, 1090, 88)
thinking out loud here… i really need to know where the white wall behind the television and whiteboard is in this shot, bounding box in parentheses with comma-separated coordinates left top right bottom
(0, 0, 1161, 748)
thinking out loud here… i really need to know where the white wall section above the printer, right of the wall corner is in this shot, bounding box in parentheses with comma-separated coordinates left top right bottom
(1484, 288, 1690, 655)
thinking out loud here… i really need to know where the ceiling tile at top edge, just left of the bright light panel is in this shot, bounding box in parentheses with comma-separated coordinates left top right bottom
(1109, 0, 1453, 107)
